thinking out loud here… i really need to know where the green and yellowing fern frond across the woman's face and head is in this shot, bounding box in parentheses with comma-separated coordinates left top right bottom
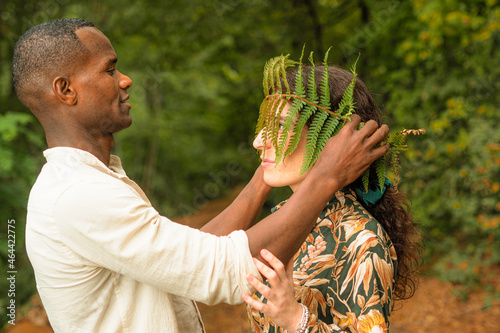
(256, 47, 425, 190)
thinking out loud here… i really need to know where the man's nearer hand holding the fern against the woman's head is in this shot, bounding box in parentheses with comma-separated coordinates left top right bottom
(309, 115, 389, 188)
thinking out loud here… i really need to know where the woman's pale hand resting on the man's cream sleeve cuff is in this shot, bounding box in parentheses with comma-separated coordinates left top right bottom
(242, 249, 303, 332)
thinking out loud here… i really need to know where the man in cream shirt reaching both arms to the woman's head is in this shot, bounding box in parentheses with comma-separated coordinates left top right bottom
(13, 19, 388, 333)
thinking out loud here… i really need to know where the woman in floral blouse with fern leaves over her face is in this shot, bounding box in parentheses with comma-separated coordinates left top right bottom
(243, 66, 421, 333)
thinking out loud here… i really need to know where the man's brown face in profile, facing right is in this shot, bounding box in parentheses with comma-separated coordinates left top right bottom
(71, 27, 132, 135)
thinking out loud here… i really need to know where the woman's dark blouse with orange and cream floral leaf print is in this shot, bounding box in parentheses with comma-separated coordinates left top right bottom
(247, 188, 397, 333)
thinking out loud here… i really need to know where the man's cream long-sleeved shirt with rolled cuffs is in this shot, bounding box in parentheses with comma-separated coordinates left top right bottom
(26, 147, 260, 333)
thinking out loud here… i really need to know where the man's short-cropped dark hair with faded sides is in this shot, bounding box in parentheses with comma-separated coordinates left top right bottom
(12, 18, 94, 104)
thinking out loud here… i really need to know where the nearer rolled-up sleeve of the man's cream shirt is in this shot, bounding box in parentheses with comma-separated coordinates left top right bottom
(54, 178, 260, 304)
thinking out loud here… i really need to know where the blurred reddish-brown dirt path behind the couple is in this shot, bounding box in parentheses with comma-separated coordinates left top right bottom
(4, 185, 500, 333)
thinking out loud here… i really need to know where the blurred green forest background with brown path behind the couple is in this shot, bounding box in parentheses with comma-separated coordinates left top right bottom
(0, 0, 500, 332)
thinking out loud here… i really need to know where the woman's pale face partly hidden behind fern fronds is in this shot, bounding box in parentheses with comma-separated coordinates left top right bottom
(253, 103, 309, 191)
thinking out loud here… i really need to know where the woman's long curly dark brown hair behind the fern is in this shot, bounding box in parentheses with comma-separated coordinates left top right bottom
(287, 66, 423, 300)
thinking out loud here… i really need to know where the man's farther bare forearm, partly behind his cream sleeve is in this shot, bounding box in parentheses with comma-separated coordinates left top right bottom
(201, 168, 272, 236)
